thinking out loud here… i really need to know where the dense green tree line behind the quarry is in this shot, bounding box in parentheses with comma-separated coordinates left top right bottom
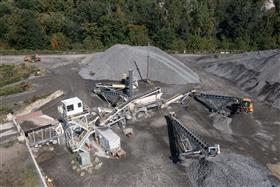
(0, 0, 280, 51)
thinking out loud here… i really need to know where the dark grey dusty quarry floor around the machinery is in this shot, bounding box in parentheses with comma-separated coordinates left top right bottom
(1, 53, 280, 186)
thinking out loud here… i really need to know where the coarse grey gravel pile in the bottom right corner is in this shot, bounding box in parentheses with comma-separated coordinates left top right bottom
(184, 153, 280, 187)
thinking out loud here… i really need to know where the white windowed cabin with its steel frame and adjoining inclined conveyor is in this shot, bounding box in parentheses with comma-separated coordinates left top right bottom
(58, 88, 162, 156)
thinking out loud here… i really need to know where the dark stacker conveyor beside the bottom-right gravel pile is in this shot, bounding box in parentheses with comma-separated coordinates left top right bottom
(165, 112, 220, 163)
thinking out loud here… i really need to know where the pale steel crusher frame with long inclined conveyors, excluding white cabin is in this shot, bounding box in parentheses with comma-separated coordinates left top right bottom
(65, 88, 197, 152)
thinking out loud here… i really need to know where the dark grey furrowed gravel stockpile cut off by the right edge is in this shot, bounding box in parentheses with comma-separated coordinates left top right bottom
(202, 50, 280, 108)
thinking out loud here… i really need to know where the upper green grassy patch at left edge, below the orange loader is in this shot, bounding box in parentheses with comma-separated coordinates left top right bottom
(0, 63, 39, 87)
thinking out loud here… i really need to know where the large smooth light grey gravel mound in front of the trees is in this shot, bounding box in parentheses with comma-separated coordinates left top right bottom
(79, 45, 200, 85)
